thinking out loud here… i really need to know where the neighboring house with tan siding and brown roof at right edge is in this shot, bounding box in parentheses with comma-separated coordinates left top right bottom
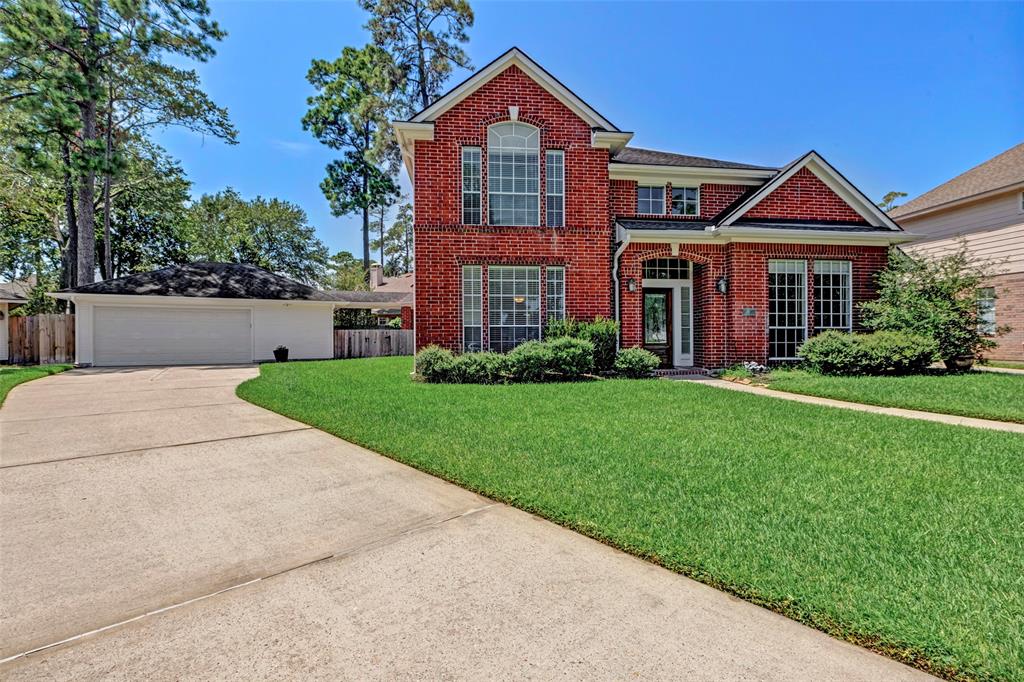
(889, 143, 1024, 360)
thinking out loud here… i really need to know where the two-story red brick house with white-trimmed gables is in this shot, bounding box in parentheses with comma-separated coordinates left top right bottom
(394, 48, 909, 368)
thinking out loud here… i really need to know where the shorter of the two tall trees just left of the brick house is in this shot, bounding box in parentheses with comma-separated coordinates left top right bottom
(302, 45, 400, 271)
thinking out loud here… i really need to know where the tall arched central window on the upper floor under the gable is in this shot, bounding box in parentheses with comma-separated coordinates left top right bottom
(487, 122, 541, 225)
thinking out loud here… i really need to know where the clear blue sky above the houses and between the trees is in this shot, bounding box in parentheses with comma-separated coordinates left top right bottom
(153, 0, 1024, 253)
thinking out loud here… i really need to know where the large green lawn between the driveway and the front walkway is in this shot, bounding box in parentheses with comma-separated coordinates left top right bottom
(239, 357, 1024, 679)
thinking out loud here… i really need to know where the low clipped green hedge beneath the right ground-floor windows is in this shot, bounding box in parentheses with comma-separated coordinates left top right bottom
(800, 331, 938, 376)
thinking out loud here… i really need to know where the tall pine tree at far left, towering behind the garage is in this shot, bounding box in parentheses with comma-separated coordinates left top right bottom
(0, 0, 233, 284)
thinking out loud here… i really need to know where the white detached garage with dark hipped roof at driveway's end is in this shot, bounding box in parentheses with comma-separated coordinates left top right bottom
(52, 263, 336, 367)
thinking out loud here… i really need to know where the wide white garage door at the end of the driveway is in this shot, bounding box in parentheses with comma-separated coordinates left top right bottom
(93, 306, 253, 366)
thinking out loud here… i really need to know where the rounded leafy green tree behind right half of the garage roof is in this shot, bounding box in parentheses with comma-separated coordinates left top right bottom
(186, 188, 328, 284)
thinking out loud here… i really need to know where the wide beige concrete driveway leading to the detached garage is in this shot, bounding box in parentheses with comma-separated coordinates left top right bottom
(0, 368, 925, 680)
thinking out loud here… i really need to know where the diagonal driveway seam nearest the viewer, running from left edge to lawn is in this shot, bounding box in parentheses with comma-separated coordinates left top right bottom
(0, 502, 495, 666)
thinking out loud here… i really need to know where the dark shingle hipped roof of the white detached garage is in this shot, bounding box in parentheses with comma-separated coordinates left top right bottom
(65, 263, 335, 301)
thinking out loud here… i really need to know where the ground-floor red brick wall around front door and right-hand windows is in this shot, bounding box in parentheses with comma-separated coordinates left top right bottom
(621, 243, 887, 368)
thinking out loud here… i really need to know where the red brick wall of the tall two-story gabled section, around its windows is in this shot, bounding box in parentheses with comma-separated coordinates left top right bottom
(415, 67, 611, 349)
